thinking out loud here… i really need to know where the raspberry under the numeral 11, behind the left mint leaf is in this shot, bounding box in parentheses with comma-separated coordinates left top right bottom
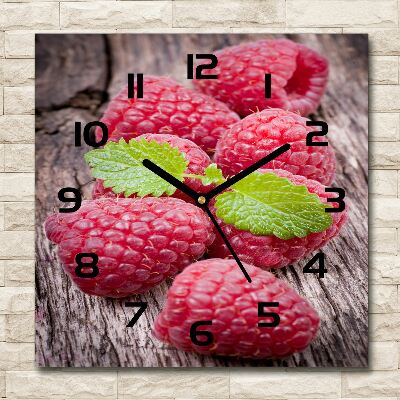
(97, 76, 239, 152)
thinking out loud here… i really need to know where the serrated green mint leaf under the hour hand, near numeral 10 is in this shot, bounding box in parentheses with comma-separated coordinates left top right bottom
(85, 139, 188, 197)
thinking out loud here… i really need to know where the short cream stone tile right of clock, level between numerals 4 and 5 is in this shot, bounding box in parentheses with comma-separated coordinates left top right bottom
(369, 285, 400, 313)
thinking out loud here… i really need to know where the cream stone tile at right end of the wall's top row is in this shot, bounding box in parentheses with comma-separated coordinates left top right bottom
(286, 0, 398, 27)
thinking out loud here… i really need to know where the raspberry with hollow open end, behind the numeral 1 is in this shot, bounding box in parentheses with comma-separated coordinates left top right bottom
(195, 39, 328, 116)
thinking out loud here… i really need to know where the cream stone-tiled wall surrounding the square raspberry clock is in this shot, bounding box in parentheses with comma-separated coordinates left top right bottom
(0, 0, 400, 400)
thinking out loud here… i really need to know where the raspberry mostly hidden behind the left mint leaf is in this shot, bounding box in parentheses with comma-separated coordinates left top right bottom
(92, 134, 214, 202)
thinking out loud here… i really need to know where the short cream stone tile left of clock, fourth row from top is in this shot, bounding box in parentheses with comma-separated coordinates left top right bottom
(4, 86, 35, 115)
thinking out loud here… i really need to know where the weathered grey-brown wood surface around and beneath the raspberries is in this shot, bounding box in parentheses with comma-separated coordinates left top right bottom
(36, 34, 368, 367)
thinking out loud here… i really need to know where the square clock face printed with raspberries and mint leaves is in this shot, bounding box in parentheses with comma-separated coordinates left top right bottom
(36, 34, 368, 367)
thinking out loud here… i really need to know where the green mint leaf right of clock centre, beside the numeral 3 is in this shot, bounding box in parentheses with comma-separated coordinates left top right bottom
(215, 172, 332, 240)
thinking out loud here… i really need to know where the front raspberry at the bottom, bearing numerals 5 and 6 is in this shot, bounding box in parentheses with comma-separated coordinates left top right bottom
(154, 259, 319, 359)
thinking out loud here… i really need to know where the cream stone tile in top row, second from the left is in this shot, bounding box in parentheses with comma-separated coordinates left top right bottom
(60, 1, 172, 29)
